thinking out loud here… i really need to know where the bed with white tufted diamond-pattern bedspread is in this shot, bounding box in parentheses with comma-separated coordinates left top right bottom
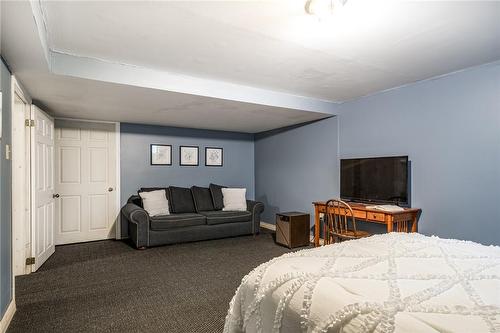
(224, 233, 500, 333)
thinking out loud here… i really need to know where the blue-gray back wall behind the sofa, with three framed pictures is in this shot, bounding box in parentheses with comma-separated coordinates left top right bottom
(120, 123, 255, 237)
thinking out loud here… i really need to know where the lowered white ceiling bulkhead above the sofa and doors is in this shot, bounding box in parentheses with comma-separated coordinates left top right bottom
(1, 1, 333, 133)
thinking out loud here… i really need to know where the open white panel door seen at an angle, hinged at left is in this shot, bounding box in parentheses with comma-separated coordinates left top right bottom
(30, 105, 55, 271)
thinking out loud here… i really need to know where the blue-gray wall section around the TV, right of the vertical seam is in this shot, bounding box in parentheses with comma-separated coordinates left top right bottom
(338, 63, 500, 245)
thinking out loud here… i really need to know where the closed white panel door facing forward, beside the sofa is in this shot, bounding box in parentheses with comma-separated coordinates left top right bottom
(55, 119, 119, 245)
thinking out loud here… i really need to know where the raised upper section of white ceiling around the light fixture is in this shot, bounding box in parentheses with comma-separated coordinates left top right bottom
(44, 0, 500, 101)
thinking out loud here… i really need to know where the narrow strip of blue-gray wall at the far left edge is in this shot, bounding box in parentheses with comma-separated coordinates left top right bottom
(0, 60, 13, 319)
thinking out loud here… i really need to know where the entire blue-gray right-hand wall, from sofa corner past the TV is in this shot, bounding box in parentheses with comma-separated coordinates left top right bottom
(255, 63, 500, 245)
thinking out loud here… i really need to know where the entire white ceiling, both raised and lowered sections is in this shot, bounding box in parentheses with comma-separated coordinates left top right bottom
(1, 0, 500, 132)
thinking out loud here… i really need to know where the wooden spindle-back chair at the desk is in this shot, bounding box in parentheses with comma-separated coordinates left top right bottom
(324, 199, 371, 245)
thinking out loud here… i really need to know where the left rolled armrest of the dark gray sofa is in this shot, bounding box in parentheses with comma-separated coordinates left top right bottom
(121, 203, 149, 248)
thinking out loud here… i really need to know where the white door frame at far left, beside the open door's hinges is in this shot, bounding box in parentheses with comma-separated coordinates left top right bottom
(11, 76, 32, 276)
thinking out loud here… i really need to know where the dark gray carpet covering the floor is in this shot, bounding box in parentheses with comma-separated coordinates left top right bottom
(8, 232, 296, 333)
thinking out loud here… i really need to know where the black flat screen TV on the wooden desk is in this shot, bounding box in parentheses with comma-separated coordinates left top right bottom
(340, 156, 409, 206)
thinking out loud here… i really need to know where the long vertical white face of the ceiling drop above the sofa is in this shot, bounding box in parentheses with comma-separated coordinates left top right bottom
(50, 51, 338, 114)
